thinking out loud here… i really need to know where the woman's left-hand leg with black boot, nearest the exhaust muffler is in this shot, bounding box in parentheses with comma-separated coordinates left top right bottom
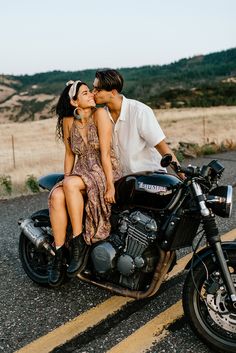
(48, 186, 68, 287)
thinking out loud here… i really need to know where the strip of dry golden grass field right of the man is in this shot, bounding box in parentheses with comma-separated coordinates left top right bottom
(156, 107, 236, 148)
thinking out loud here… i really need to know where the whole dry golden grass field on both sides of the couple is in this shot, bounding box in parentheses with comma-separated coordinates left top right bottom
(0, 107, 236, 197)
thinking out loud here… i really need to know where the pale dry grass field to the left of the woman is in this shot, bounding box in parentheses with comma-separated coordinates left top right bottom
(0, 119, 64, 194)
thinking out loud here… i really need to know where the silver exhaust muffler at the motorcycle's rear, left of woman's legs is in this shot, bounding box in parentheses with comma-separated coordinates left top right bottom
(18, 218, 55, 256)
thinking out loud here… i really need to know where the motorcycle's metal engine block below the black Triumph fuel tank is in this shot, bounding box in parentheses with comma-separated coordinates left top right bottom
(91, 211, 158, 289)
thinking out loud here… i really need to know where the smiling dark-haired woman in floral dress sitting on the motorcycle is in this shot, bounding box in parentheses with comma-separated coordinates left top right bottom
(49, 81, 121, 286)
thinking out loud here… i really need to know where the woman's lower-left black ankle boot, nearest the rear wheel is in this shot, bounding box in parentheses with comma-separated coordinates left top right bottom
(48, 246, 66, 287)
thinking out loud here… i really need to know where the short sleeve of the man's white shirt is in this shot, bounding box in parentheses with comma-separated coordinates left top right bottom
(139, 107, 165, 147)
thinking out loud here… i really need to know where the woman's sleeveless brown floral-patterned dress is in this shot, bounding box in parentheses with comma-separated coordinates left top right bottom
(48, 118, 121, 244)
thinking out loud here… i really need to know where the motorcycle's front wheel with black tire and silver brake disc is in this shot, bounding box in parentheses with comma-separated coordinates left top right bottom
(183, 250, 236, 353)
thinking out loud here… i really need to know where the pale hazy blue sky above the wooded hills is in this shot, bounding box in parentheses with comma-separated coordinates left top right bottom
(0, 0, 236, 75)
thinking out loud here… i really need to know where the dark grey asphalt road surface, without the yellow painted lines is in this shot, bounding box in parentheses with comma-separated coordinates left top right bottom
(0, 152, 236, 353)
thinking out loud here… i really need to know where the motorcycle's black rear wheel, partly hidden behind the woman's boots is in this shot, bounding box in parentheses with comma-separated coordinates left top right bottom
(19, 233, 52, 286)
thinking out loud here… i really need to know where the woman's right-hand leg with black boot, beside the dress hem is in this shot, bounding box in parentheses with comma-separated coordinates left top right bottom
(63, 176, 87, 277)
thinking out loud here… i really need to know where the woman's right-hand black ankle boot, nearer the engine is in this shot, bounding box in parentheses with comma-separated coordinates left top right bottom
(67, 235, 88, 277)
